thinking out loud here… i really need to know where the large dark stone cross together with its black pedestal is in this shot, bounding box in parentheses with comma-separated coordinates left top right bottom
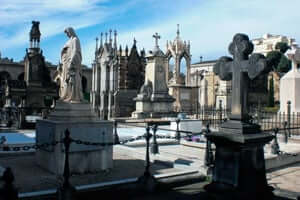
(205, 33, 273, 199)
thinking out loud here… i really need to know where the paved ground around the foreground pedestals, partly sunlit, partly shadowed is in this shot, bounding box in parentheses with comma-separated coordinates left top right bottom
(0, 134, 300, 200)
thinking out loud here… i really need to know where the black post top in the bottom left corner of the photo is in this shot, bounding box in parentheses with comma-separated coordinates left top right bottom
(0, 167, 19, 200)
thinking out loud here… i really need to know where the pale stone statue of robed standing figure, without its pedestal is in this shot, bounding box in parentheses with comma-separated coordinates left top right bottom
(60, 27, 83, 103)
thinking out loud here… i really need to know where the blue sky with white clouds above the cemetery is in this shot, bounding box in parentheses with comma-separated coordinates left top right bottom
(0, 0, 300, 67)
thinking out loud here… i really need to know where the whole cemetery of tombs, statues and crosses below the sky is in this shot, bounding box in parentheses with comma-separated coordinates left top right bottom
(0, 6, 300, 200)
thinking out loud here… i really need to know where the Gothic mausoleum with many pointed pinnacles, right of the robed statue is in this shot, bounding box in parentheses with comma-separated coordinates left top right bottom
(91, 30, 146, 119)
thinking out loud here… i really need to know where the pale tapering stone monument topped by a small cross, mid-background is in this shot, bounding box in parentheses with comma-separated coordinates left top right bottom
(132, 33, 175, 119)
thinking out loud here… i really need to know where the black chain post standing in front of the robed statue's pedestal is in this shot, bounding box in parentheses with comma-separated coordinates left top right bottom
(57, 129, 76, 200)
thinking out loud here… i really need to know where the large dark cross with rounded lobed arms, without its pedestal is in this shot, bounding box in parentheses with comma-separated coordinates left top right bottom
(214, 33, 270, 121)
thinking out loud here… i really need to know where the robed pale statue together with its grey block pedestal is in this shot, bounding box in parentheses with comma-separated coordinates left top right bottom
(36, 27, 113, 174)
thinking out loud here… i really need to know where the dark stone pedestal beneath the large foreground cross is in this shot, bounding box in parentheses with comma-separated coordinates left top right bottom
(205, 120, 273, 199)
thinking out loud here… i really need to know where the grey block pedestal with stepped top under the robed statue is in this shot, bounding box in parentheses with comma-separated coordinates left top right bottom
(36, 102, 113, 175)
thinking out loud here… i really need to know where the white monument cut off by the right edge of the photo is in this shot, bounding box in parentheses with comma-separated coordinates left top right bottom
(279, 46, 300, 114)
